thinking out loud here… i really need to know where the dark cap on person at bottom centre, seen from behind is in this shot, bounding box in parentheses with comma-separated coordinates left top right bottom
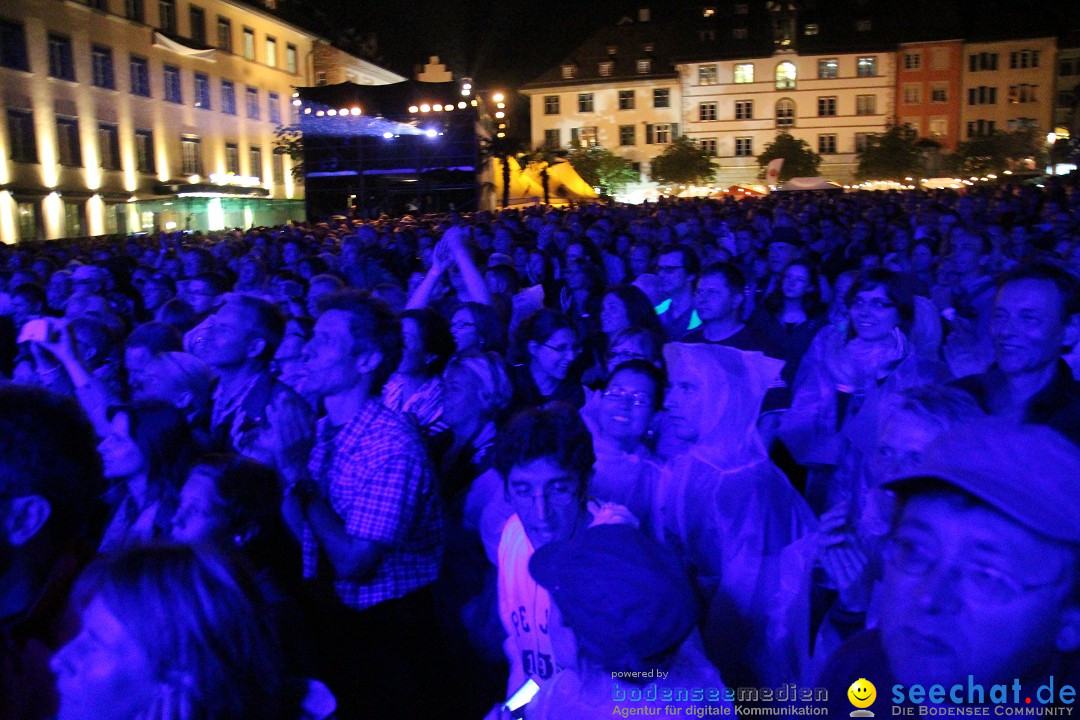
(529, 525, 699, 663)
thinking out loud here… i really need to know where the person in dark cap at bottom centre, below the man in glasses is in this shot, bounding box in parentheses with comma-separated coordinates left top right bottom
(525, 525, 725, 720)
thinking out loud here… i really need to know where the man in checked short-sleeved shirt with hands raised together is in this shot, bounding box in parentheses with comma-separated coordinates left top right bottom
(267, 290, 442, 718)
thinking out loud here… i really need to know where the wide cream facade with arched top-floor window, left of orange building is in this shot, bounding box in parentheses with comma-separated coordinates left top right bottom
(678, 50, 895, 186)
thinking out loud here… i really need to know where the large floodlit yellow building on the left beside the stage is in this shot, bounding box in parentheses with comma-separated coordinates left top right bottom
(0, 0, 402, 243)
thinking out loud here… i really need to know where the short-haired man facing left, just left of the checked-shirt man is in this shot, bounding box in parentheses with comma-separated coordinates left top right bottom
(189, 294, 312, 459)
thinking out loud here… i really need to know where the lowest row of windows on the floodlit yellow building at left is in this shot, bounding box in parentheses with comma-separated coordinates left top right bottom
(8, 109, 285, 185)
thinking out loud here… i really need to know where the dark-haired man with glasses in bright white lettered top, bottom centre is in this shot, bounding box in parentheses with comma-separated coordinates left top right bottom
(495, 404, 633, 696)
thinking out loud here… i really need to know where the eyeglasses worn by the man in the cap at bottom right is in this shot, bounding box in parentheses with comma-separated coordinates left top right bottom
(882, 535, 1062, 604)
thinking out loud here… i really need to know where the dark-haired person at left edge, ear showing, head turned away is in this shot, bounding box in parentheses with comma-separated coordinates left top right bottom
(0, 385, 105, 720)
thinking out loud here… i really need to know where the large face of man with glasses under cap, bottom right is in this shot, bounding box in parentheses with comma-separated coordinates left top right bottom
(881, 492, 1080, 687)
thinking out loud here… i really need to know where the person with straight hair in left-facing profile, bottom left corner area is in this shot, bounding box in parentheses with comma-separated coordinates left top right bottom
(52, 545, 298, 720)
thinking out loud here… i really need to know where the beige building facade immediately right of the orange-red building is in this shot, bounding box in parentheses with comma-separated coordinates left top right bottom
(960, 37, 1057, 140)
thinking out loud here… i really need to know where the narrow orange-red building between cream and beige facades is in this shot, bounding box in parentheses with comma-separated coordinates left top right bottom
(896, 40, 963, 151)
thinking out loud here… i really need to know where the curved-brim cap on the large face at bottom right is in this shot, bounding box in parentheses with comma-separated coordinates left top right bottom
(882, 418, 1080, 543)
